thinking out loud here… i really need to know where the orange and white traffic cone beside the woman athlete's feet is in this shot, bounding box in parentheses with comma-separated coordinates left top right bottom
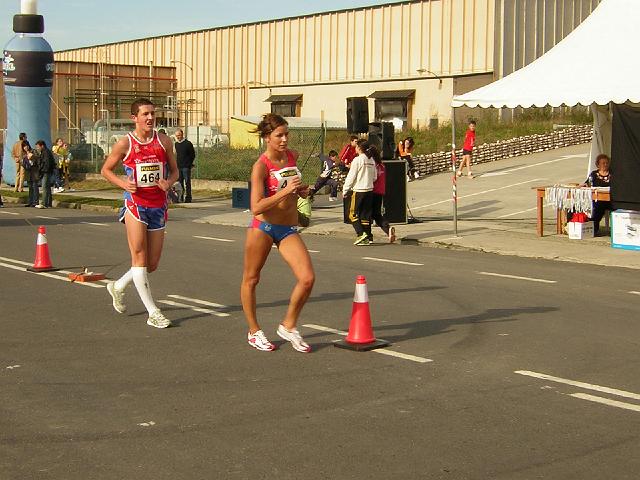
(334, 275, 389, 351)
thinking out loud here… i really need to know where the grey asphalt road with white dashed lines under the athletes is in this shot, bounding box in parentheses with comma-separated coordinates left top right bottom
(0, 208, 640, 480)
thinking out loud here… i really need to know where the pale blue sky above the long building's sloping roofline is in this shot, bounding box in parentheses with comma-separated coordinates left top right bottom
(0, 0, 395, 51)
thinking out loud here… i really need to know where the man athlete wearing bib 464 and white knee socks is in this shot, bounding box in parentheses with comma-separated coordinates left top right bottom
(101, 98, 178, 328)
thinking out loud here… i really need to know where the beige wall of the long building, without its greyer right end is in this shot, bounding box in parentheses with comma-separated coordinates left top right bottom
(55, 0, 495, 131)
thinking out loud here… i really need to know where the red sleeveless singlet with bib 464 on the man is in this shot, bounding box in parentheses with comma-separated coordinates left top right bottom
(122, 131, 168, 208)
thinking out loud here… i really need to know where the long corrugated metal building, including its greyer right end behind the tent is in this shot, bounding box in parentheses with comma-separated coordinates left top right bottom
(54, 0, 599, 131)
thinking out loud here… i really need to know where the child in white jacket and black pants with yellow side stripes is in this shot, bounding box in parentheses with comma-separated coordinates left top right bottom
(342, 139, 376, 245)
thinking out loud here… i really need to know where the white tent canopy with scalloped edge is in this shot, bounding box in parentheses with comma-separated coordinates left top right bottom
(451, 0, 640, 108)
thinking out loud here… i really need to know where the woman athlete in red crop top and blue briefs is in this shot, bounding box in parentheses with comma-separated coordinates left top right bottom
(240, 113, 315, 353)
